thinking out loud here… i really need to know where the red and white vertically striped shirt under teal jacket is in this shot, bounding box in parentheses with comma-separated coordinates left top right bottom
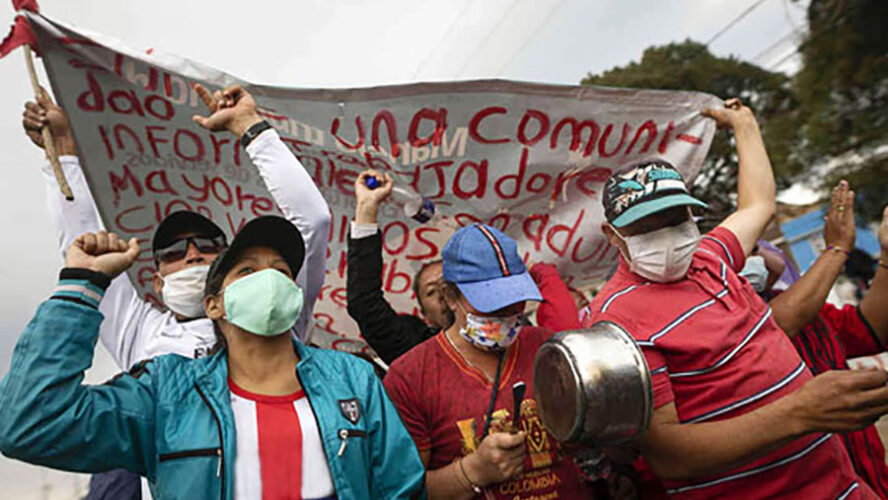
(228, 379, 336, 500)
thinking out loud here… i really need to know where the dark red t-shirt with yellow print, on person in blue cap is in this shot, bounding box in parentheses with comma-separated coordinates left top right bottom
(384, 327, 593, 500)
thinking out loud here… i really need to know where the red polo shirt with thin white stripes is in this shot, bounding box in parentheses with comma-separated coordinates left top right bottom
(587, 228, 876, 500)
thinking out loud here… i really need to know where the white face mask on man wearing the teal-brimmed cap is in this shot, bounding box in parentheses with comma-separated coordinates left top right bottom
(614, 220, 700, 283)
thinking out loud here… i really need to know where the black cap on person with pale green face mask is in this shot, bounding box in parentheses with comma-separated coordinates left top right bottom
(204, 215, 305, 295)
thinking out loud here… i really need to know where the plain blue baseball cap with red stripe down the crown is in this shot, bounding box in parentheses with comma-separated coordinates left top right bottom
(441, 224, 543, 313)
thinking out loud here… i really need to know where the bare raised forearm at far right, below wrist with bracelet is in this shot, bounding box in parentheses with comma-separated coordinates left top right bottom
(770, 250, 846, 337)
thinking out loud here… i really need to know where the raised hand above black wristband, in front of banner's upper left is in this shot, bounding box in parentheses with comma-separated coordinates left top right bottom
(192, 83, 262, 137)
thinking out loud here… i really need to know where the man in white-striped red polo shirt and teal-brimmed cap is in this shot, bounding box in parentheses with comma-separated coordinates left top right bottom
(589, 99, 888, 500)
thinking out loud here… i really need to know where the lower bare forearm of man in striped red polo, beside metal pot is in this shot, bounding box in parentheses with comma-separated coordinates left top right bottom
(642, 398, 804, 479)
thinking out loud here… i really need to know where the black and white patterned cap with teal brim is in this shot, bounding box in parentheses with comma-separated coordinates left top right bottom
(601, 159, 707, 227)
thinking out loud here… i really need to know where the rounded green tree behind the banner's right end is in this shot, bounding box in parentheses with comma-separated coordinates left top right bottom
(581, 40, 803, 227)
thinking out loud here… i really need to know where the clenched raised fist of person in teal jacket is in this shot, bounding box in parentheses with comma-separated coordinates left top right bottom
(65, 231, 140, 279)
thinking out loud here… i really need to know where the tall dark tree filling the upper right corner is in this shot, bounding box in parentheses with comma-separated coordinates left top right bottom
(793, 0, 888, 220)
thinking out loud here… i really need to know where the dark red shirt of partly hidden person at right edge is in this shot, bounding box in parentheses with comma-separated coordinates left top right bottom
(792, 304, 888, 500)
